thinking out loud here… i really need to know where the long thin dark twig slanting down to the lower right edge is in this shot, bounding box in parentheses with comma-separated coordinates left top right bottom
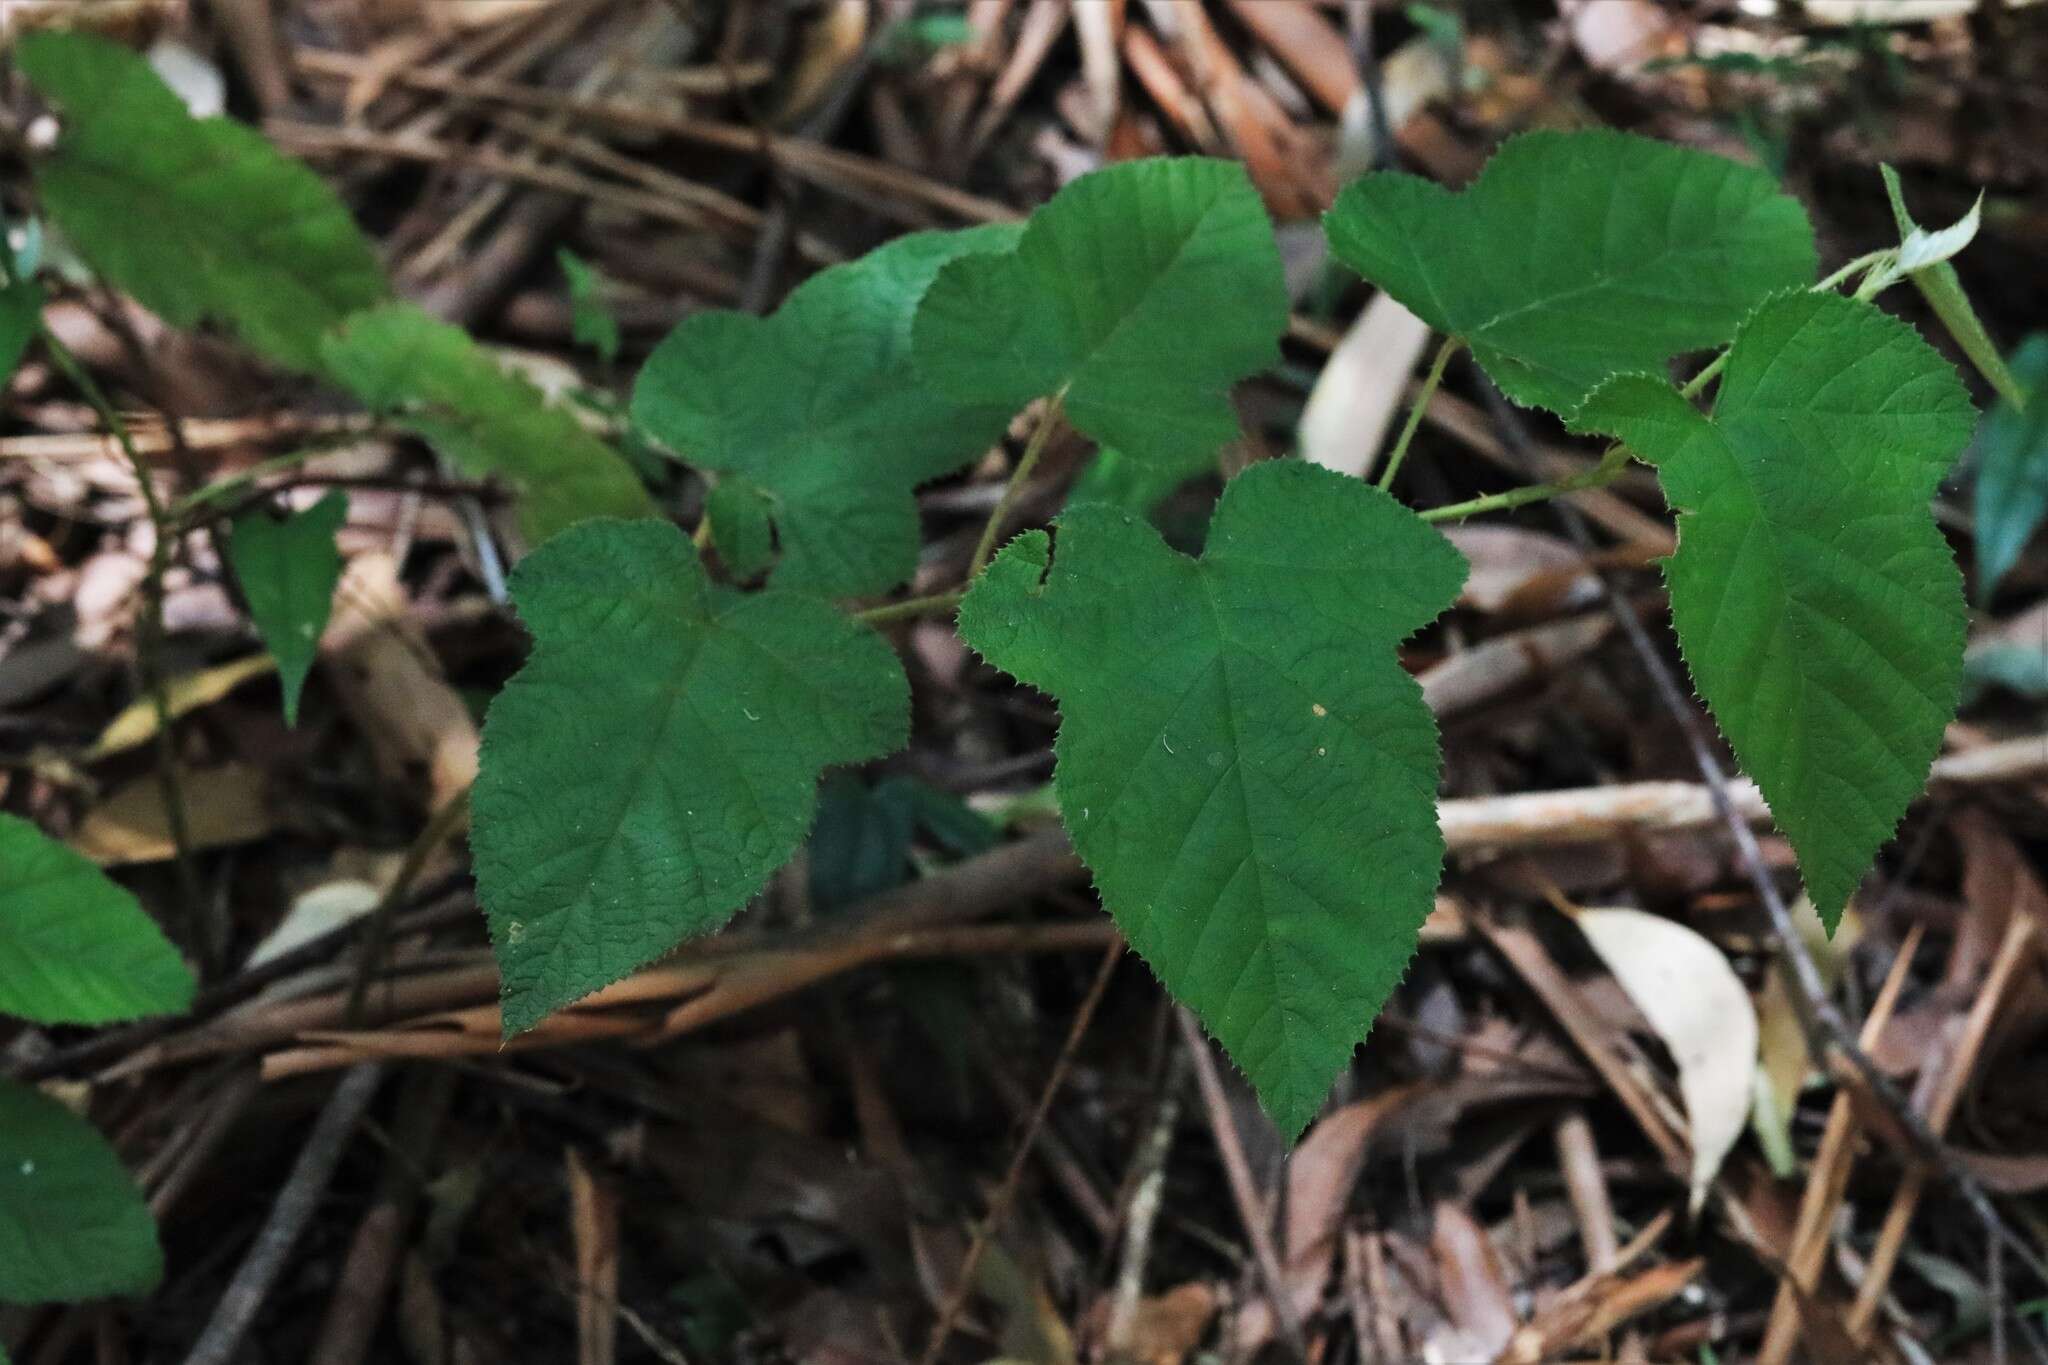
(1523, 397, 2048, 1336)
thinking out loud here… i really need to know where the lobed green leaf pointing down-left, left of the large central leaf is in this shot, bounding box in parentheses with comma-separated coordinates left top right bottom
(473, 520, 909, 1036)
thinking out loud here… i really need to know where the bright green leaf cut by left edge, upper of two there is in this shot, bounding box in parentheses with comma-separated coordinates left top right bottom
(0, 814, 193, 1023)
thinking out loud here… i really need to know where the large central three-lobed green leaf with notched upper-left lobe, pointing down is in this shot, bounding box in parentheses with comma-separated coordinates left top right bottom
(961, 460, 1464, 1136)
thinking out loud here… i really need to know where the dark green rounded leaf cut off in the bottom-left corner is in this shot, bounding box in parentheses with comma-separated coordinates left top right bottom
(0, 1081, 164, 1304)
